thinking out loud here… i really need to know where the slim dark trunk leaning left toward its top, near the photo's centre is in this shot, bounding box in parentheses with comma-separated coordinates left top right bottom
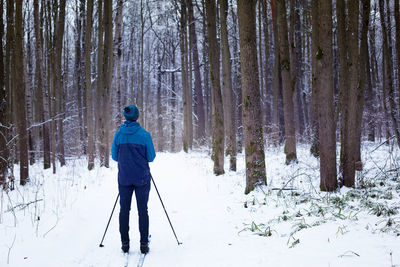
(188, 0, 206, 145)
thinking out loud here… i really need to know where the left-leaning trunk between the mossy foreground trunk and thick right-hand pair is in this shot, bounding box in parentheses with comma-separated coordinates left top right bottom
(277, 0, 297, 164)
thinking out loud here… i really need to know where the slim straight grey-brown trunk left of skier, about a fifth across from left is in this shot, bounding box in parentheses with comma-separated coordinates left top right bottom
(85, 0, 95, 170)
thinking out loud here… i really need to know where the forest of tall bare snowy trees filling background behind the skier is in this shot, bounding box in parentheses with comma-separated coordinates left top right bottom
(0, 0, 400, 193)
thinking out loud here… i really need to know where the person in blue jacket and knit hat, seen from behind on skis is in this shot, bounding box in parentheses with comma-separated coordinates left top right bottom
(111, 105, 156, 254)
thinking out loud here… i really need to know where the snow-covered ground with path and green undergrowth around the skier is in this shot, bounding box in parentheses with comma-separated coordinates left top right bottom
(0, 144, 400, 267)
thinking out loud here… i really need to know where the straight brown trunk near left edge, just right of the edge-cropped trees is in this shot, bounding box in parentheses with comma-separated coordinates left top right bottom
(13, 1, 29, 185)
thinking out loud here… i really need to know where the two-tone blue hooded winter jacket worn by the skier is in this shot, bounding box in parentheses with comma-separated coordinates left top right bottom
(111, 121, 156, 186)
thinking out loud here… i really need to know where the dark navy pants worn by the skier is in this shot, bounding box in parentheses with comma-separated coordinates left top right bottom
(118, 181, 150, 243)
